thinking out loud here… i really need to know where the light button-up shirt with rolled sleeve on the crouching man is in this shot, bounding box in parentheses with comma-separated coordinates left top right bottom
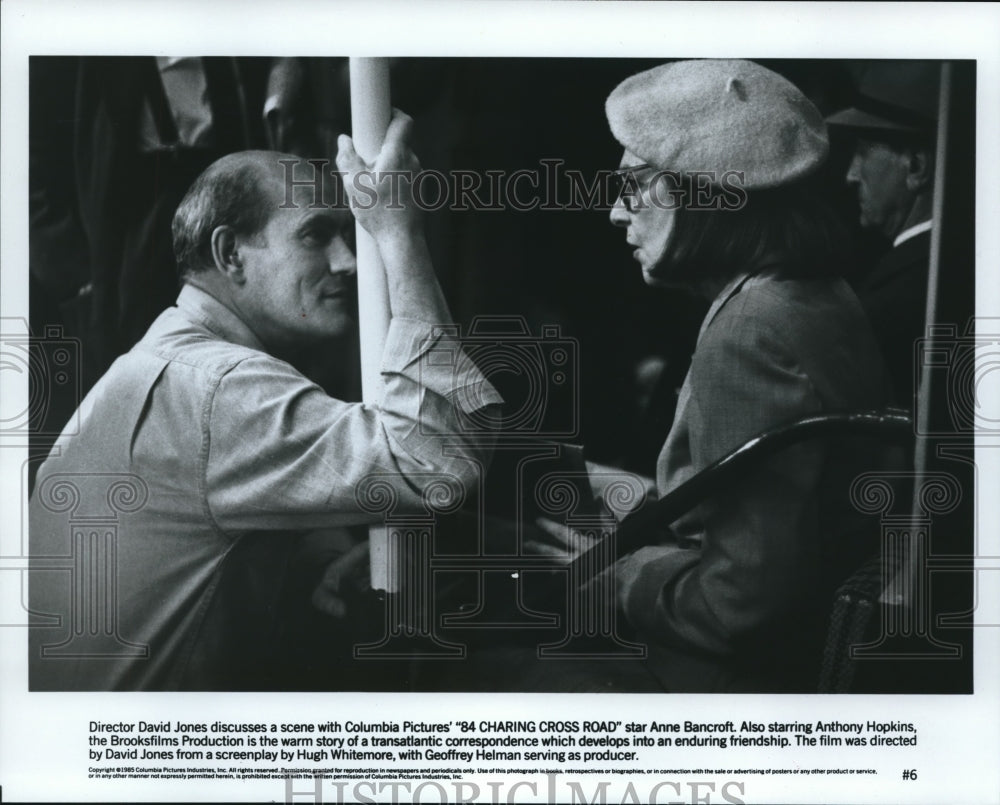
(30, 286, 501, 690)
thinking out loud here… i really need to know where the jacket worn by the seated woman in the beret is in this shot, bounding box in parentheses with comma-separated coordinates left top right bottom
(625, 273, 885, 690)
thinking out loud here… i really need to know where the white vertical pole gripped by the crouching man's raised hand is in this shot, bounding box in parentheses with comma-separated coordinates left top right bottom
(350, 57, 397, 592)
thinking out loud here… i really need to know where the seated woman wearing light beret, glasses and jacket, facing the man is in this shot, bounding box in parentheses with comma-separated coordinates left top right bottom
(606, 60, 885, 691)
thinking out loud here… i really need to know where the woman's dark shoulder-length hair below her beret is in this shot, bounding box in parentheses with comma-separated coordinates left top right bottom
(652, 180, 851, 281)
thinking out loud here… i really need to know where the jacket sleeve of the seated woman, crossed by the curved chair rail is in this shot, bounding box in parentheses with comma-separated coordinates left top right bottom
(623, 304, 825, 655)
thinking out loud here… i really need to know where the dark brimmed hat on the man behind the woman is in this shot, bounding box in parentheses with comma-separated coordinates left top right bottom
(826, 60, 941, 134)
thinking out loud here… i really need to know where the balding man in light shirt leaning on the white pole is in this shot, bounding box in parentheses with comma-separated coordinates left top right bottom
(29, 113, 501, 690)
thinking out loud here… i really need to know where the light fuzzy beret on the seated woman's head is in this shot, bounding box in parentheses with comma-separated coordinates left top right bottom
(605, 59, 830, 190)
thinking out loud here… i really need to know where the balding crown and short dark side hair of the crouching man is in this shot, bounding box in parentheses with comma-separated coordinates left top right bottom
(171, 151, 298, 279)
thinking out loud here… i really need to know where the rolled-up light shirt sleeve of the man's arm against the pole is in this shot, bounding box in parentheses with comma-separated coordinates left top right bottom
(204, 319, 502, 532)
